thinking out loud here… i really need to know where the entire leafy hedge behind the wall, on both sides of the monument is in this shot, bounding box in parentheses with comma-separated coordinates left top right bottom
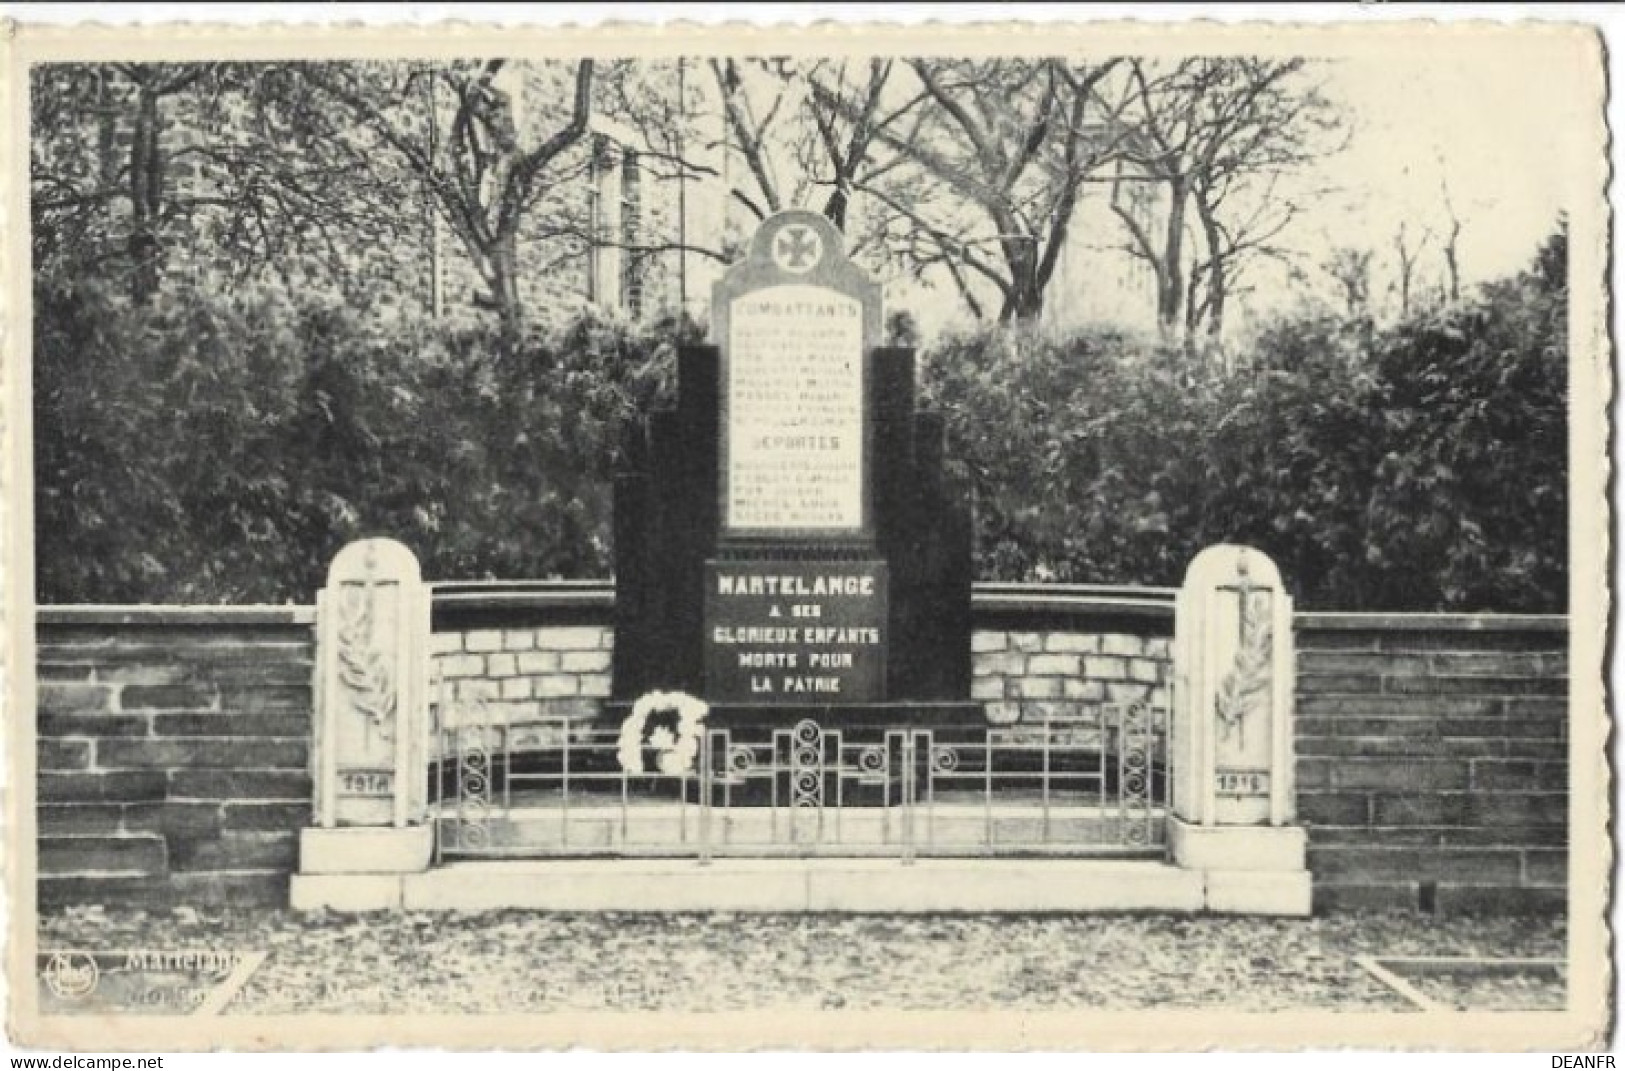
(34, 236, 1568, 611)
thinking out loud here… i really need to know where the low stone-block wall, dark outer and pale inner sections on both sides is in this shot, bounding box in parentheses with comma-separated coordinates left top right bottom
(36, 596, 1568, 912)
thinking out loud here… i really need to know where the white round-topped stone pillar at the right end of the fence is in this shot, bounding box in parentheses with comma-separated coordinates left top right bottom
(1168, 544, 1310, 915)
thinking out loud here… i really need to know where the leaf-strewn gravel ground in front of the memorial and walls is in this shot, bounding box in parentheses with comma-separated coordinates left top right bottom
(39, 908, 1565, 1014)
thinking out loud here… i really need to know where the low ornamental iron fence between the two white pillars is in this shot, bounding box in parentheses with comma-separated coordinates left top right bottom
(431, 702, 1168, 861)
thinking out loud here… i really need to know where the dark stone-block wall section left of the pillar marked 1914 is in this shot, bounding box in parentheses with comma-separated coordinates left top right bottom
(36, 608, 314, 907)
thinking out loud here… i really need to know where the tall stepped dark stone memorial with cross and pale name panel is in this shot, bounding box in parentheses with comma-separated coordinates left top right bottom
(614, 211, 980, 723)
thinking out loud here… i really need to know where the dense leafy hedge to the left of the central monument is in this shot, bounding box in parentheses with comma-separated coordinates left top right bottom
(34, 288, 674, 603)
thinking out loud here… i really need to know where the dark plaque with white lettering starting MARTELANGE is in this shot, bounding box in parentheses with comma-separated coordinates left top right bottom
(705, 561, 886, 704)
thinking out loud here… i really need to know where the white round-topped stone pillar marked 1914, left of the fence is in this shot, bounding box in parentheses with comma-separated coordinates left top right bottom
(293, 540, 434, 910)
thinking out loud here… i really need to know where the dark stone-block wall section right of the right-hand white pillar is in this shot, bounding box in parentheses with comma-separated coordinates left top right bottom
(1297, 614, 1568, 913)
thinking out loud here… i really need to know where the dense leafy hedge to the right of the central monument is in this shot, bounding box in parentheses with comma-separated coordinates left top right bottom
(928, 234, 1568, 611)
